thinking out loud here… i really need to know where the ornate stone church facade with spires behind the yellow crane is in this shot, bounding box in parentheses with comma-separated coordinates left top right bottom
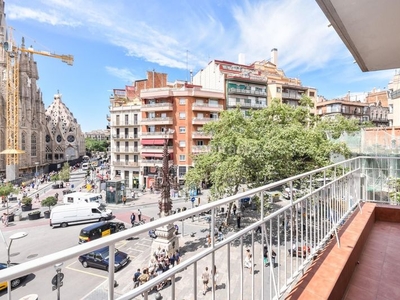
(0, 0, 85, 176)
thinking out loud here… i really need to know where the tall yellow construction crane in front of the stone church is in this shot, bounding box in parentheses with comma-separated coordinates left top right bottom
(0, 27, 74, 180)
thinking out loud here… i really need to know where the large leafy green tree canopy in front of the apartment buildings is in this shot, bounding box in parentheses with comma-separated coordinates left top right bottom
(185, 97, 359, 199)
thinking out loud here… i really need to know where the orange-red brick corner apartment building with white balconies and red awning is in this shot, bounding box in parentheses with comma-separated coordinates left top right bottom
(140, 82, 224, 187)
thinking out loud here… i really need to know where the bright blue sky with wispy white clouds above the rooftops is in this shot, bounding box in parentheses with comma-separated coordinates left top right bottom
(5, 0, 394, 131)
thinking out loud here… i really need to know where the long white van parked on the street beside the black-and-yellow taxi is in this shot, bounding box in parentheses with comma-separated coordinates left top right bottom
(50, 203, 112, 227)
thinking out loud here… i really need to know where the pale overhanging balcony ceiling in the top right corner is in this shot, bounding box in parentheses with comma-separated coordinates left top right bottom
(316, 0, 400, 72)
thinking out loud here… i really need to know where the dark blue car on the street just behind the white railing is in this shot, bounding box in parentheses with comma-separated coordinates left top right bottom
(78, 246, 130, 272)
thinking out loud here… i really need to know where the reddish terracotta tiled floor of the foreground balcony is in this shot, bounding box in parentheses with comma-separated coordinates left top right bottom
(344, 222, 400, 300)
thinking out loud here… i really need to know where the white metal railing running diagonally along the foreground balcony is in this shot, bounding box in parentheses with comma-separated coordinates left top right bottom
(0, 157, 400, 300)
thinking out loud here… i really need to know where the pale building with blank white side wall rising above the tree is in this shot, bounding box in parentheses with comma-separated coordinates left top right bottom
(193, 49, 317, 111)
